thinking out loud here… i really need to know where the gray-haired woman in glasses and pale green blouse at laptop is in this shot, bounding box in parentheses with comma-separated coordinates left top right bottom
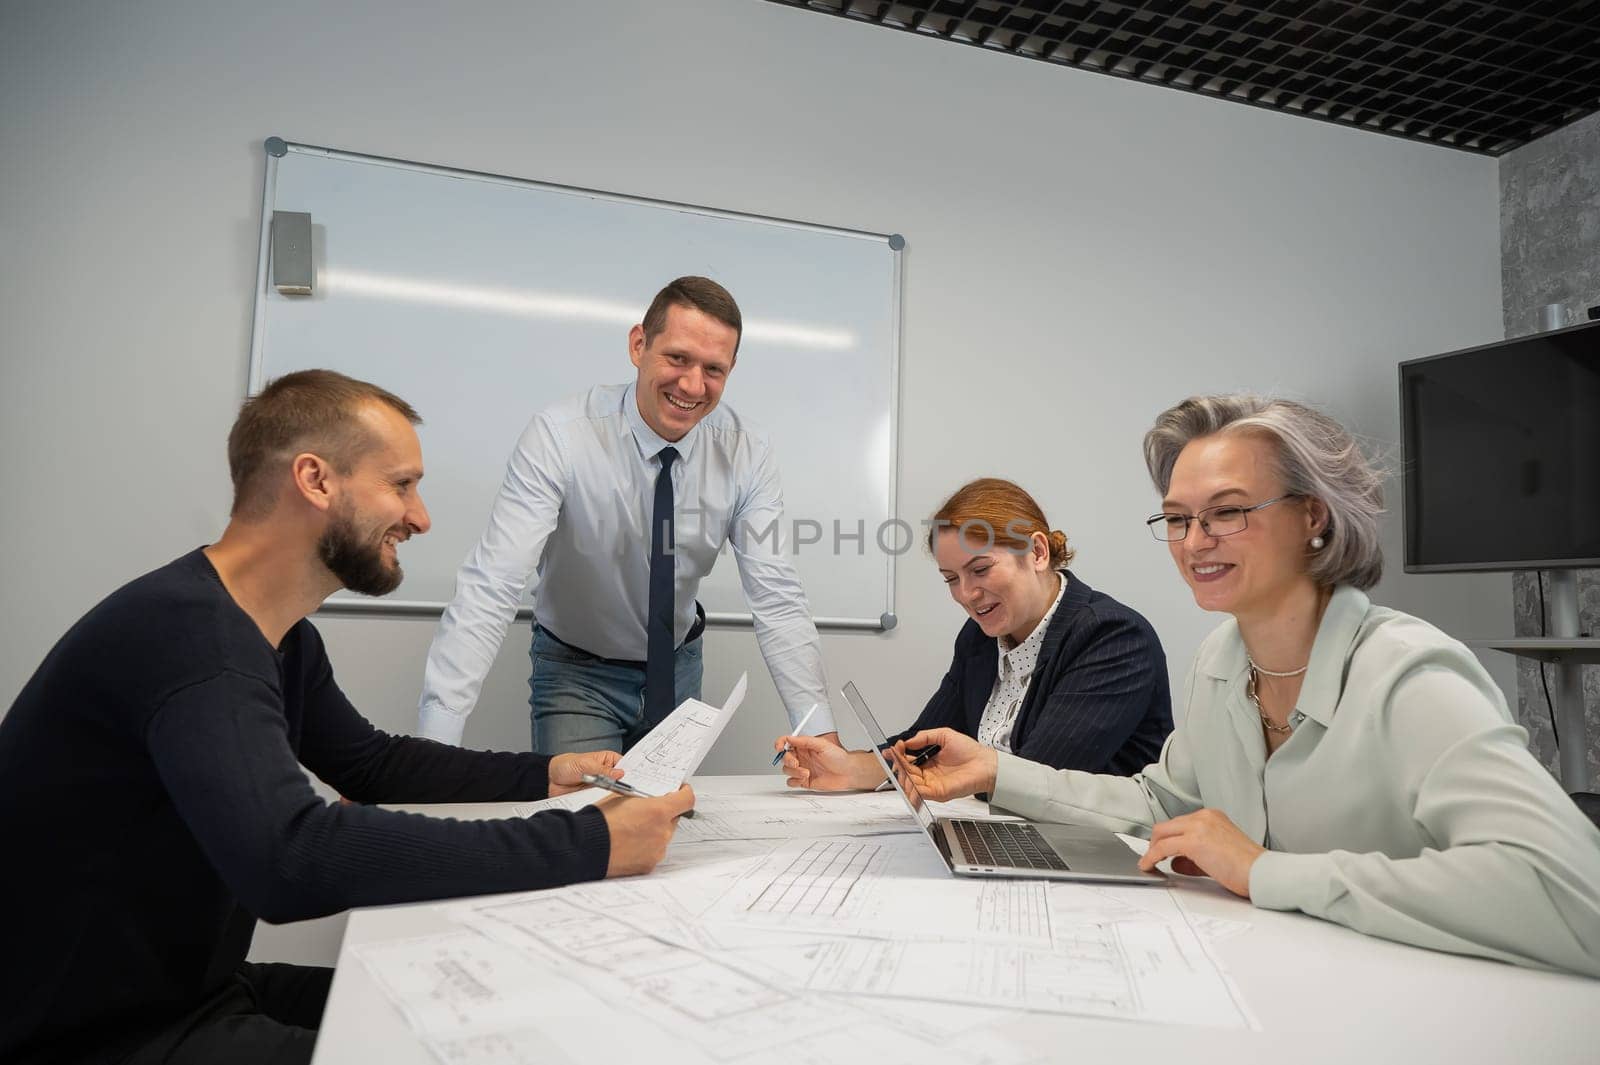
(904, 395, 1600, 975)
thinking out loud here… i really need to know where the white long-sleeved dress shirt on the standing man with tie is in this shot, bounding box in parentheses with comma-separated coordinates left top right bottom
(418, 384, 835, 744)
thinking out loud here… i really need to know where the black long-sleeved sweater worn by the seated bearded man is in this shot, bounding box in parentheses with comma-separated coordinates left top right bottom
(0, 550, 610, 1062)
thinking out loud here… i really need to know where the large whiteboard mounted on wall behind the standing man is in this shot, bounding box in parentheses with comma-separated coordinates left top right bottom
(250, 138, 909, 628)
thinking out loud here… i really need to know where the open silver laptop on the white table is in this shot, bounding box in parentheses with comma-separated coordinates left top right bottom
(843, 684, 1166, 884)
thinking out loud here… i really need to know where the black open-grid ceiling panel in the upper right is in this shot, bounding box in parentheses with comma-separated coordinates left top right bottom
(768, 0, 1600, 155)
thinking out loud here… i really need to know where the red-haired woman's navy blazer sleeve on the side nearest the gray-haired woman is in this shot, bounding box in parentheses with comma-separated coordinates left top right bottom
(1013, 604, 1166, 772)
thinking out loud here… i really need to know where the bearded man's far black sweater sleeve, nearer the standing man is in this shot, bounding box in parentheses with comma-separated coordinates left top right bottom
(299, 624, 550, 803)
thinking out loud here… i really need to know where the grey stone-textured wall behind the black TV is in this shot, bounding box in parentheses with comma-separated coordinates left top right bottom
(1501, 114, 1600, 792)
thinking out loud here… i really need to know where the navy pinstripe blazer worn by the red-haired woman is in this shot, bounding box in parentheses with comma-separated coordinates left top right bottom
(896, 571, 1173, 776)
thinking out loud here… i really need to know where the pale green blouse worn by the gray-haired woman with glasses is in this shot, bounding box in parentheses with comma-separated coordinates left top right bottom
(994, 587, 1600, 977)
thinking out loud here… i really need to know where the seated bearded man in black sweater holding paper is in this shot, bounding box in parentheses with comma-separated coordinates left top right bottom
(0, 371, 693, 1065)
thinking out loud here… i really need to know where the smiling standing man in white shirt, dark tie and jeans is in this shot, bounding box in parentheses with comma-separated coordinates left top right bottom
(418, 277, 838, 755)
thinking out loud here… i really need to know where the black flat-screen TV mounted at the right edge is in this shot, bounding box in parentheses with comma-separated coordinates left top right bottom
(1400, 321, 1600, 572)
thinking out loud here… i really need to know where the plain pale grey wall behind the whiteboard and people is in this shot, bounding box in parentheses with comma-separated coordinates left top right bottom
(0, 0, 1512, 953)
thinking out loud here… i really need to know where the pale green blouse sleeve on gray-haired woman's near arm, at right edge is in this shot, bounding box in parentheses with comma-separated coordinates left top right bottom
(1250, 668, 1600, 977)
